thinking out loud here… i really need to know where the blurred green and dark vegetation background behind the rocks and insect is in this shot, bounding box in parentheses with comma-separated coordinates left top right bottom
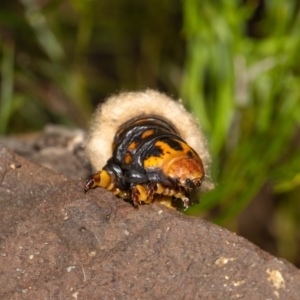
(0, 0, 300, 266)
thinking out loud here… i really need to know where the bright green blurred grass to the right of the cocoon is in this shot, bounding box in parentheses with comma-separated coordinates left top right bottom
(182, 0, 300, 261)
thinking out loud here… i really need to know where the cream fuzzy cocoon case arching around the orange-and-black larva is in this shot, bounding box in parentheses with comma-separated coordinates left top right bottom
(86, 89, 214, 190)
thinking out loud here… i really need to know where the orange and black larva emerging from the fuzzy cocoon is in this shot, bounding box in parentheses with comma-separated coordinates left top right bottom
(85, 115, 204, 208)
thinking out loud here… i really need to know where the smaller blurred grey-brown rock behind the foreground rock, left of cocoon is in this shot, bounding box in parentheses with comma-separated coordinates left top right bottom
(0, 125, 91, 179)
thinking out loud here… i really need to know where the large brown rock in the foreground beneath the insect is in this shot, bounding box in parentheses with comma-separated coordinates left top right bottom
(0, 129, 300, 299)
